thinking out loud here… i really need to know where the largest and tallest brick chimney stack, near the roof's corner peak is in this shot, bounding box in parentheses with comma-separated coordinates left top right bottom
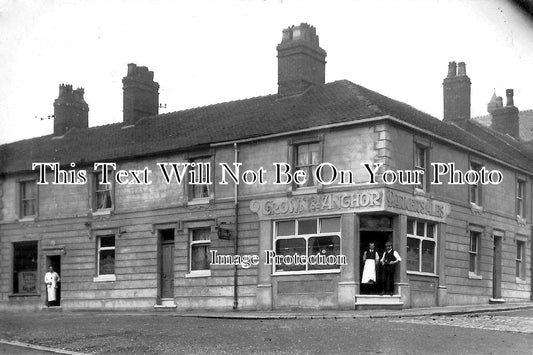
(277, 23, 326, 96)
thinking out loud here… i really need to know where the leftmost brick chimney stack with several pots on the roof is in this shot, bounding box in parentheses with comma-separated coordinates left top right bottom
(54, 84, 89, 136)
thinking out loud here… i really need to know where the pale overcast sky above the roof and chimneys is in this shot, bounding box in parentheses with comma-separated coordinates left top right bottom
(0, 0, 533, 144)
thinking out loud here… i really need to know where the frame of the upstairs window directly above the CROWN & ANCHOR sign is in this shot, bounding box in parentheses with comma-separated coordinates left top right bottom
(287, 133, 324, 195)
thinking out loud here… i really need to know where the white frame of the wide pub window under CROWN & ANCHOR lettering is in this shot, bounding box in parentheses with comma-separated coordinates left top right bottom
(272, 215, 342, 276)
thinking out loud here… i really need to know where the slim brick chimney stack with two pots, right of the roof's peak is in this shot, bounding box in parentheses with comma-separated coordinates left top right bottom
(442, 62, 471, 122)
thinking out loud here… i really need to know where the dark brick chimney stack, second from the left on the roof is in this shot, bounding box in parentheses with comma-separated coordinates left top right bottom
(122, 63, 159, 125)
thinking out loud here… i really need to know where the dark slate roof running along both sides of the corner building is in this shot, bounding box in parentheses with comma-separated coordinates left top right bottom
(0, 80, 533, 174)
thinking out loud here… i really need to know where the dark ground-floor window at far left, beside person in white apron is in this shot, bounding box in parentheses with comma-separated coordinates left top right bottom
(13, 241, 39, 294)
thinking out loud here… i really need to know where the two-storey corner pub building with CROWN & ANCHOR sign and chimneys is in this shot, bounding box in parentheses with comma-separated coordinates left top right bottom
(0, 24, 533, 310)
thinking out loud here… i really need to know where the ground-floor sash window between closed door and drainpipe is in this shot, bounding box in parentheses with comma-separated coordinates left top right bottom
(189, 228, 211, 276)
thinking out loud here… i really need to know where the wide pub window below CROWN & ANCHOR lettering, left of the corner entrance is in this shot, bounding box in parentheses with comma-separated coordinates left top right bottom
(267, 217, 344, 272)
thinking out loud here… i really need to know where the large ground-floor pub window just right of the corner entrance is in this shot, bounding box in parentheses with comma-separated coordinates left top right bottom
(407, 219, 437, 274)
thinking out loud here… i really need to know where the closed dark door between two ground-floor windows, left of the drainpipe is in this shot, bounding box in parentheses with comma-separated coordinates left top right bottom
(159, 229, 174, 300)
